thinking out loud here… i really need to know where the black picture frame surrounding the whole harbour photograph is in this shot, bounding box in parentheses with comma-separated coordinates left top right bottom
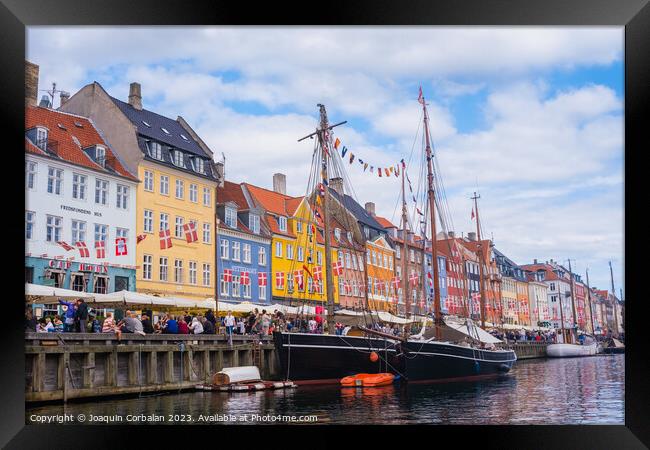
(0, 0, 650, 450)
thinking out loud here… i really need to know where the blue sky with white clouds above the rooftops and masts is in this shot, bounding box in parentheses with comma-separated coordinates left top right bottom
(27, 27, 624, 296)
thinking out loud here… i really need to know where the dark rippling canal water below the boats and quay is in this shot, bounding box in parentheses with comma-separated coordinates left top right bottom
(26, 355, 625, 425)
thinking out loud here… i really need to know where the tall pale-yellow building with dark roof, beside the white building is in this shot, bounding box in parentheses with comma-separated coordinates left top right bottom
(61, 82, 222, 299)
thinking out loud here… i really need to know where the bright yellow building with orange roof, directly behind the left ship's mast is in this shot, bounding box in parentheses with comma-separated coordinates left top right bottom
(243, 177, 338, 305)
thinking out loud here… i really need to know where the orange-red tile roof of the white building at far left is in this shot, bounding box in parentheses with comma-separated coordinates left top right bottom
(25, 106, 138, 181)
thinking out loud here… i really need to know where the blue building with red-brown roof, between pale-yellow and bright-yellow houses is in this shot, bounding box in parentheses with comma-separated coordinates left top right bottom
(216, 181, 272, 304)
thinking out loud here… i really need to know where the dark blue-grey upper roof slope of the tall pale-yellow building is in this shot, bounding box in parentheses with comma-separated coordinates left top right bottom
(109, 95, 212, 159)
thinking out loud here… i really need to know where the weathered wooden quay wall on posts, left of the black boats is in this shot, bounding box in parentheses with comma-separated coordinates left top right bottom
(25, 333, 279, 402)
